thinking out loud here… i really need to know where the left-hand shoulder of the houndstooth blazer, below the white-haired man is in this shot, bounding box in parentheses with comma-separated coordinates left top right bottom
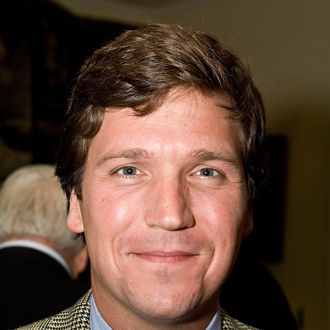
(18, 290, 91, 330)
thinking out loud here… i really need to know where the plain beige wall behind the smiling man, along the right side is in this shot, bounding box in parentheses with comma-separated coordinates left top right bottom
(52, 0, 330, 330)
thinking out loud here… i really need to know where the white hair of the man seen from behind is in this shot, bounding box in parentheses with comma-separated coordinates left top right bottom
(0, 164, 82, 254)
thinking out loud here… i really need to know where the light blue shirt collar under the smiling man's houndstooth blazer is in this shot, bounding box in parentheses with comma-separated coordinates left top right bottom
(90, 295, 221, 330)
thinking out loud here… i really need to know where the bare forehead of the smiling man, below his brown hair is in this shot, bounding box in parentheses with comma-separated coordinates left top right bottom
(89, 90, 241, 162)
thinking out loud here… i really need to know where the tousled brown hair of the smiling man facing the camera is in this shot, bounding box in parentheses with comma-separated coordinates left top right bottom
(56, 24, 264, 200)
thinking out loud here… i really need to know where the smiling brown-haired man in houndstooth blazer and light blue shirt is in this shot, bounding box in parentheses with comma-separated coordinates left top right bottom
(20, 25, 264, 330)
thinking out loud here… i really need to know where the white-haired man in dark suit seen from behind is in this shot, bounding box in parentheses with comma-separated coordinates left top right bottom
(0, 165, 87, 329)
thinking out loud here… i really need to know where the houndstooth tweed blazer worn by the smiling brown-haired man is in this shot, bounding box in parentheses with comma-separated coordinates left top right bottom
(18, 290, 257, 330)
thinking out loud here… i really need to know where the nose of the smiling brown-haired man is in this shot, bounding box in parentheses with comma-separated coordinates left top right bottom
(145, 178, 195, 231)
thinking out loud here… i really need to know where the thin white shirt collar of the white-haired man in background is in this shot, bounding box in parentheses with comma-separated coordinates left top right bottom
(0, 239, 71, 275)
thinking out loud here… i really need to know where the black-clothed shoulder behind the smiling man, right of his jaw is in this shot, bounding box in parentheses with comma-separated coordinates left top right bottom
(220, 251, 298, 330)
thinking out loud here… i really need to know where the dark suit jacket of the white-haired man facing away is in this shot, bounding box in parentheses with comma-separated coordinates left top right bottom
(0, 247, 82, 329)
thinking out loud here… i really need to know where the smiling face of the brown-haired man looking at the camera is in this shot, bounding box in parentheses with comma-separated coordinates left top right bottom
(68, 91, 251, 328)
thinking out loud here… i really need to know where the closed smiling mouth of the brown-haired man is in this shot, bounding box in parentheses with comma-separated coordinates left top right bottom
(131, 251, 198, 264)
